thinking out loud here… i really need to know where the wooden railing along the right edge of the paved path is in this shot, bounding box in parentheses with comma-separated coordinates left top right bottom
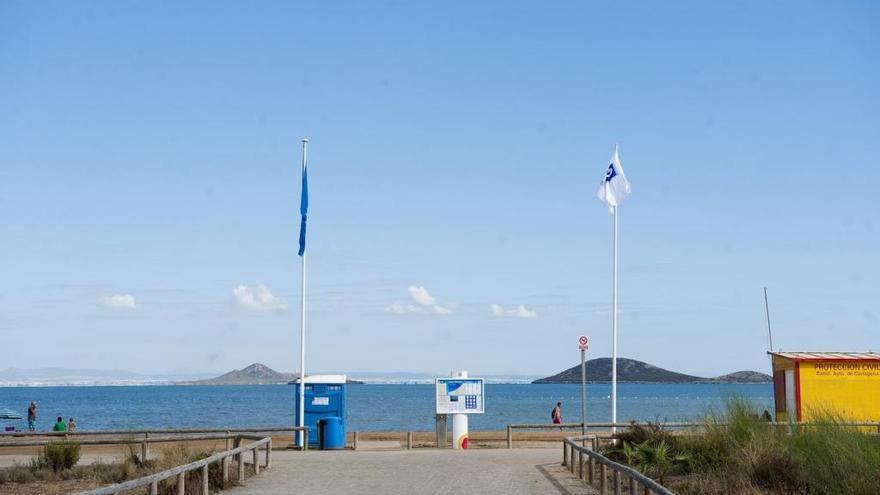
(562, 435, 675, 495)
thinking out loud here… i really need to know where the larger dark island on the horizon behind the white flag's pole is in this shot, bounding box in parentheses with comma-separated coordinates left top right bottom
(532, 358, 773, 384)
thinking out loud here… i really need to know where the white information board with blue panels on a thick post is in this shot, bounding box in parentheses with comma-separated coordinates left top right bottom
(436, 371, 485, 450)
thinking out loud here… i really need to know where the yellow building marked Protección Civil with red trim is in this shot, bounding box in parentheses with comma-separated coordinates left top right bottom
(770, 352, 880, 422)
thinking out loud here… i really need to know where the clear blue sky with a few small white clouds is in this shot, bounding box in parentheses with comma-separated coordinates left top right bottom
(0, 0, 880, 376)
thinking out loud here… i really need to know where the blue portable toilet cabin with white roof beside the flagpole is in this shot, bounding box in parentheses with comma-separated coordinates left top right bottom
(293, 375, 348, 448)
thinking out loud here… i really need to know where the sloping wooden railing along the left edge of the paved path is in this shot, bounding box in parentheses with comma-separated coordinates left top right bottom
(81, 435, 272, 495)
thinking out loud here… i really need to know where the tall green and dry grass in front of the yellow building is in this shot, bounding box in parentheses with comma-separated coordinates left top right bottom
(606, 398, 880, 495)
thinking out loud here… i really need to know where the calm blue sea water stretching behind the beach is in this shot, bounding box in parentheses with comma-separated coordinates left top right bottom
(0, 383, 773, 431)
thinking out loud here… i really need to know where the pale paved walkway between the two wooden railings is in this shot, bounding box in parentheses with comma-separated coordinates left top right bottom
(225, 449, 596, 495)
